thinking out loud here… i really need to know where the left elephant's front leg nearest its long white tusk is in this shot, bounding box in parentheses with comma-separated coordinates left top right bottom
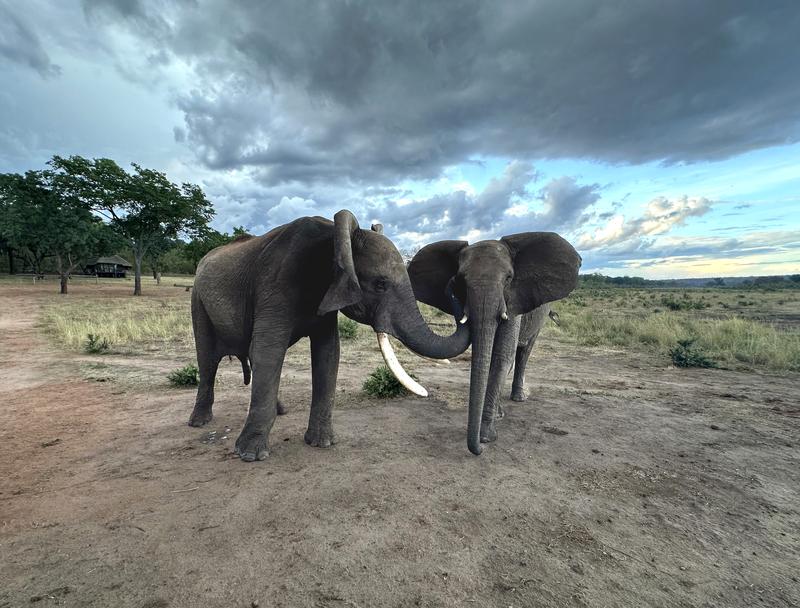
(304, 311, 339, 448)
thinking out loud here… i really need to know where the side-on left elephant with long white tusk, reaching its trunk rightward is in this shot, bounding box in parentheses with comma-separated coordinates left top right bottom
(189, 210, 470, 462)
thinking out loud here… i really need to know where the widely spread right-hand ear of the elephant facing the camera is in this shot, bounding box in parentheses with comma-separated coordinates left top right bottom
(500, 232, 581, 315)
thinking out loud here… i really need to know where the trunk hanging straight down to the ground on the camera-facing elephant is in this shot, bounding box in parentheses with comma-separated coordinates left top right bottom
(467, 299, 499, 456)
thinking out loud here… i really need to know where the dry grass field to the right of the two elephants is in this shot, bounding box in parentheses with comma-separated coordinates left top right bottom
(548, 289, 800, 371)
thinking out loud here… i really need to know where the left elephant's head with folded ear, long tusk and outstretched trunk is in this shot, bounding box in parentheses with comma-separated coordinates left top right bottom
(317, 210, 469, 396)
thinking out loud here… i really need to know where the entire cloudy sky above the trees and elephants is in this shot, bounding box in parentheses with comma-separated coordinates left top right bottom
(0, 0, 800, 279)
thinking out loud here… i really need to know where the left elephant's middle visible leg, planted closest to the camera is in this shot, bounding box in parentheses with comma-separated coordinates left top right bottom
(234, 323, 289, 462)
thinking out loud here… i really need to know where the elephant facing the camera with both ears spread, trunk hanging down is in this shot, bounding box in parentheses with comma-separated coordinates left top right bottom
(408, 232, 581, 454)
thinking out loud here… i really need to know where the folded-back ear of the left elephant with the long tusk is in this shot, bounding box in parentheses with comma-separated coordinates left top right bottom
(317, 209, 362, 315)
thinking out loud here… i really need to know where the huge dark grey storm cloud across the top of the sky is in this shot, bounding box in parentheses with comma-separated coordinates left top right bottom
(73, 0, 800, 183)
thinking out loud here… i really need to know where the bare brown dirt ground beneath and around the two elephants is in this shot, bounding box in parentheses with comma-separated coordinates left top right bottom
(0, 285, 800, 608)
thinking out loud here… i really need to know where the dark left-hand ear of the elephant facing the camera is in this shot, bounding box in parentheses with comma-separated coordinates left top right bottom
(408, 241, 467, 314)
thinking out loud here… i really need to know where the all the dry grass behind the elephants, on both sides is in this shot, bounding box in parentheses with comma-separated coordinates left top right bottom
(34, 277, 800, 372)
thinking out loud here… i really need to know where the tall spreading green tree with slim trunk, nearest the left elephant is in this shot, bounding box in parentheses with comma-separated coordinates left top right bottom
(49, 156, 214, 295)
